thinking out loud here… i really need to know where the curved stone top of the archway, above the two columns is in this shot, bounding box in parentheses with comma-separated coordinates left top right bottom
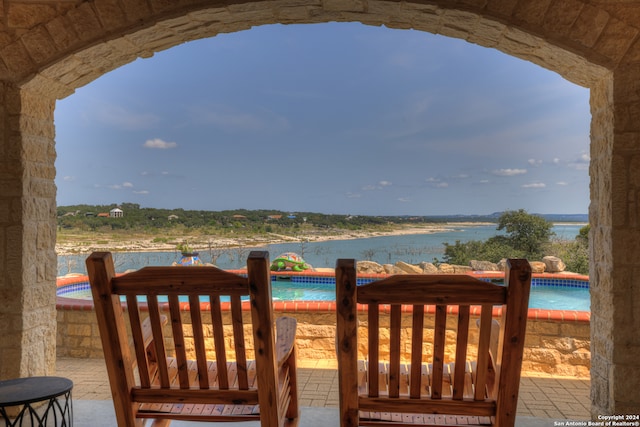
(0, 0, 640, 98)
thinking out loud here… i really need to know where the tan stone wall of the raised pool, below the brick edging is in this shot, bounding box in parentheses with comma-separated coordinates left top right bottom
(57, 305, 591, 378)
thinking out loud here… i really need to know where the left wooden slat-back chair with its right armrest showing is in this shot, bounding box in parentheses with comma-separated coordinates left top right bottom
(86, 252, 298, 427)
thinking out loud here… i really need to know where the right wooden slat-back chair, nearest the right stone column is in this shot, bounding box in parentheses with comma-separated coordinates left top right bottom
(336, 259, 531, 427)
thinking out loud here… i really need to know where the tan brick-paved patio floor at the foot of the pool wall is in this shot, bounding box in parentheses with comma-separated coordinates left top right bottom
(56, 358, 590, 425)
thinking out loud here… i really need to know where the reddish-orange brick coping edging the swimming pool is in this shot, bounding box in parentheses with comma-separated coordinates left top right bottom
(56, 270, 591, 323)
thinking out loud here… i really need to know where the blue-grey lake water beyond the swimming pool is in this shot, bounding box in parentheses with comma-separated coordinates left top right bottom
(58, 224, 583, 276)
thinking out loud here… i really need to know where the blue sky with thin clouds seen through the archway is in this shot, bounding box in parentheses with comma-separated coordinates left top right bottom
(55, 23, 591, 215)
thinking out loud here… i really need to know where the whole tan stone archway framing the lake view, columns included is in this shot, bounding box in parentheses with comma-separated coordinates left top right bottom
(0, 0, 640, 415)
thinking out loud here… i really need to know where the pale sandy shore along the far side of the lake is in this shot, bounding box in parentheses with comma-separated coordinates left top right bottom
(56, 223, 487, 255)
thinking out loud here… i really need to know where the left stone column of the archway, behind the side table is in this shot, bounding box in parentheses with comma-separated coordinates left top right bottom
(0, 83, 57, 379)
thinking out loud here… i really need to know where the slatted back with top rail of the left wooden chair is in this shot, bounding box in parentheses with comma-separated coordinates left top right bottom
(112, 267, 252, 398)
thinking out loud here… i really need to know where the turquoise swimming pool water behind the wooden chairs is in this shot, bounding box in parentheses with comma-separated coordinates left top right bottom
(57, 275, 591, 311)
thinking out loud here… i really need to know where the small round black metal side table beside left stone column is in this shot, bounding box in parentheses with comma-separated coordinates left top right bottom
(0, 377, 73, 427)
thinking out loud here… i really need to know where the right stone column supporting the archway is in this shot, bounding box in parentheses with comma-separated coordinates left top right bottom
(589, 65, 640, 417)
